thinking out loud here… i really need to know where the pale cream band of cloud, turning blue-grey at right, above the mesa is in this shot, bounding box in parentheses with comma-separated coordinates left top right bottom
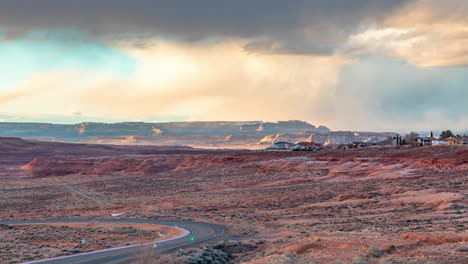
(2, 41, 468, 131)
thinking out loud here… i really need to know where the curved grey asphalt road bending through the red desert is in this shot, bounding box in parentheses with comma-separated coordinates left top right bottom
(0, 219, 224, 264)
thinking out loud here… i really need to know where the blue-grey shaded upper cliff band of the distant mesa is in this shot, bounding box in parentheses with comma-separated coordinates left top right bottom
(0, 120, 330, 138)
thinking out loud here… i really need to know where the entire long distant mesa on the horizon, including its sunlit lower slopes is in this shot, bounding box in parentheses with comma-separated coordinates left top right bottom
(0, 120, 402, 148)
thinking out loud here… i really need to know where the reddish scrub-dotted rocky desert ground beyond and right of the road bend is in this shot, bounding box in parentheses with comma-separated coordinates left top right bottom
(0, 137, 468, 263)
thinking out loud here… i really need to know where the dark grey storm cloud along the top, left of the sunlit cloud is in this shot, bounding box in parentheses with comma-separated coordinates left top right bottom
(0, 0, 408, 54)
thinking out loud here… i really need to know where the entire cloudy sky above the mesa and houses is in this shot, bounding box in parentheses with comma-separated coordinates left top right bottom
(0, 0, 468, 131)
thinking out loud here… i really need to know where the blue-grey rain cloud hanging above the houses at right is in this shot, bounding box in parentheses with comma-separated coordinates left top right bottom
(334, 56, 468, 132)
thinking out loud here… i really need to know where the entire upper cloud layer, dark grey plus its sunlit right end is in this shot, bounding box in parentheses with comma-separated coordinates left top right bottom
(0, 0, 468, 67)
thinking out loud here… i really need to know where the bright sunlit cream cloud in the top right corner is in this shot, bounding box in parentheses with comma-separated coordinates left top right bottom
(345, 0, 468, 67)
